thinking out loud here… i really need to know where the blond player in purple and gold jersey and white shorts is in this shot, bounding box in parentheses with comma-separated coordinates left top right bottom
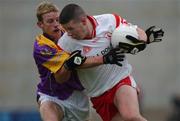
(33, 2, 89, 121)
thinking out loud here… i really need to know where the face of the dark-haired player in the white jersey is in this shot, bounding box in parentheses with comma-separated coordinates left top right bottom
(62, 20, 89, 40)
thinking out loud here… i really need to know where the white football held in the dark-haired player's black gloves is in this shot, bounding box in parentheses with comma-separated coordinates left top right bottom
(111, 24, 138, 47)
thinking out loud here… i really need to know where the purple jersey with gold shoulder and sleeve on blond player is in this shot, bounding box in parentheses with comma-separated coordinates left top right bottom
(33, 34, 84, 100)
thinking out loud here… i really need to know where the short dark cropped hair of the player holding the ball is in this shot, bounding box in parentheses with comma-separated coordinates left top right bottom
(59, 4, 86, 24)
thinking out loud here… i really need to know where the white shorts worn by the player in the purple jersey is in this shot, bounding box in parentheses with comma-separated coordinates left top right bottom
(38, 91, 90, 121)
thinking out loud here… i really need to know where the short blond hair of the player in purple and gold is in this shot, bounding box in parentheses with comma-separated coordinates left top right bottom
(36, 1, 59, 21)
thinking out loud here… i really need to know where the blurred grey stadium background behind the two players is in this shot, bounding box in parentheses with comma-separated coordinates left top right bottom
(0, 0, 180, 121)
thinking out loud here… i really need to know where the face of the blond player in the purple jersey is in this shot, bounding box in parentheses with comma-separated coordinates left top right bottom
(38, 12, 61, 39)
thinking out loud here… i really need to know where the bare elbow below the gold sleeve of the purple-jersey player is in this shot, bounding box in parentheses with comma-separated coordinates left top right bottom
(54, 66, 71, 83)
